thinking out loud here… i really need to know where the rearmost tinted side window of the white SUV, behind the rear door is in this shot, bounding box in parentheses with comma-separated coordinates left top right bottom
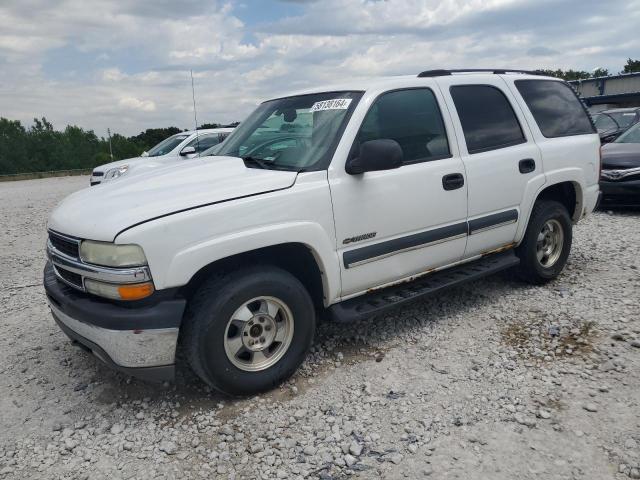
(515, 80, 595, 138)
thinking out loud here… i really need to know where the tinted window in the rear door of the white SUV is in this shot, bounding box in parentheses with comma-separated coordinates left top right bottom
(451, 85, 526, 153)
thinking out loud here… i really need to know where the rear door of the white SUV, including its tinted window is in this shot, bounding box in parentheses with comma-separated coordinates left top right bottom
(438, 75, 544, 258)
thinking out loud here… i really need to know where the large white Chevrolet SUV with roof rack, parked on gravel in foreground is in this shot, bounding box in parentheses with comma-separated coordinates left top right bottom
(44, 70, 600, 395)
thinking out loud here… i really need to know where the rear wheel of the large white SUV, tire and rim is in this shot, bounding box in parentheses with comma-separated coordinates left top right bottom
(516, 200, 572, 285)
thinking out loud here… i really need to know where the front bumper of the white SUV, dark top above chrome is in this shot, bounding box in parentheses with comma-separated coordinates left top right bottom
(44, 262, 186, 382)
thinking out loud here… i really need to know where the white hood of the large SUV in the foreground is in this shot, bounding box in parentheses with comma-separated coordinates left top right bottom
(48, 157, 297, 242)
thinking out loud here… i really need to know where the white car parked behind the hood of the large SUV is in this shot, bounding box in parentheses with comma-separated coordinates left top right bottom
(90, 127, 233, 185)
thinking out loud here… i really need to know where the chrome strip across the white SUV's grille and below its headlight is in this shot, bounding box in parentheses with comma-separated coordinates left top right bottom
(47, 245, 151, 289)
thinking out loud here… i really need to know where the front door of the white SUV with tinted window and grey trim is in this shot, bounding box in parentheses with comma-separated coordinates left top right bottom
(329, 87, 467, 297)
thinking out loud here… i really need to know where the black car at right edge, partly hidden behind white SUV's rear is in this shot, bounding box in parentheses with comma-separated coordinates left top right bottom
(600, 123, 640, 207)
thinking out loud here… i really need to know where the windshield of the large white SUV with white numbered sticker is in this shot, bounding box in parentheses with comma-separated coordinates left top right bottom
(215, 92, 362, 171)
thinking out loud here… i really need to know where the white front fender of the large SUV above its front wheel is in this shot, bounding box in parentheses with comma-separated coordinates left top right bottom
(116, 172, 340, 302)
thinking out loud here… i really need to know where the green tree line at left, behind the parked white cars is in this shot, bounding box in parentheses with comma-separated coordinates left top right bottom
(0, 117, 235, 175)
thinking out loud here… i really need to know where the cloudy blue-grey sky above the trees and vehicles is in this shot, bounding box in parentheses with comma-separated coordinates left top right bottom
(0, 0, 640, 136)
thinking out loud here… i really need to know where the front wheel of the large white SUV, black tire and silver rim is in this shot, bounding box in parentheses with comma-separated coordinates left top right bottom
(182, 266, 316, 396)
